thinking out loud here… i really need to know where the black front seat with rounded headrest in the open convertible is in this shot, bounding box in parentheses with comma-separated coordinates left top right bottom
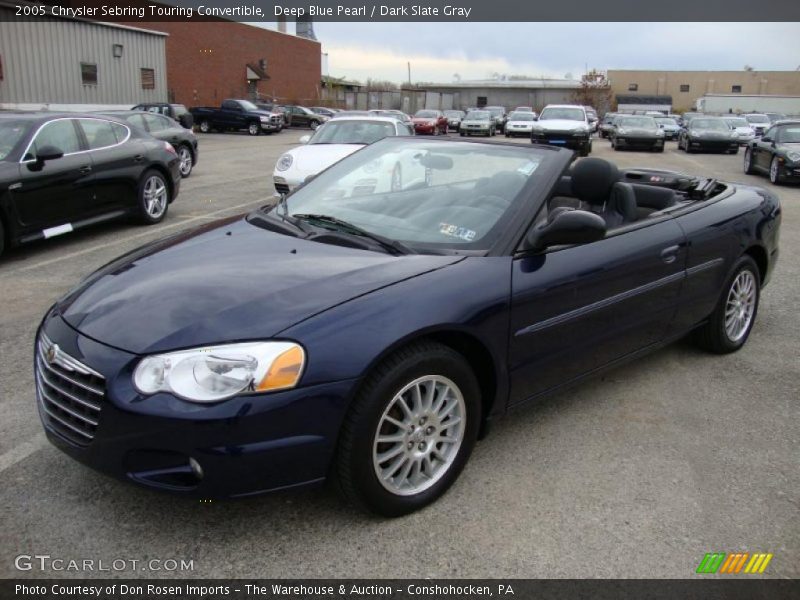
(572, 158, 637, 229)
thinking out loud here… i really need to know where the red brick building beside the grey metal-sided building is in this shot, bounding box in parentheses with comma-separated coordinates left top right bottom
(137, 21, 322, 106)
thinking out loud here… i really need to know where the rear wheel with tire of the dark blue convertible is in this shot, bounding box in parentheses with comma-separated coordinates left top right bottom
(695, 255, 761, 354)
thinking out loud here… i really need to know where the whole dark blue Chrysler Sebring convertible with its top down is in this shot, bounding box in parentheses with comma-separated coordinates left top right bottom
(35, 138, 780, 515)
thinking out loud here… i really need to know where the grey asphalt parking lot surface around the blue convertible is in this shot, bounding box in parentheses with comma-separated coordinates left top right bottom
(0, 129, 800, 578)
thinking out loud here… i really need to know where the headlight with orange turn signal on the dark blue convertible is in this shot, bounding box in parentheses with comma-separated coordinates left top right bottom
(133, 342, 305, 402)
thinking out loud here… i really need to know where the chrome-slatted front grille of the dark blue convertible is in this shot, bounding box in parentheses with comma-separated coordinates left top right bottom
(36, 334, 105, 446)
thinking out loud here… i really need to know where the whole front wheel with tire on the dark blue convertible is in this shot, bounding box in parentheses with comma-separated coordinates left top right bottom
(335, 341, 481, 517)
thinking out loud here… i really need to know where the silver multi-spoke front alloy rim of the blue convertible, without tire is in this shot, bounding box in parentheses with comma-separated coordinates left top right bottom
(372, 375, 467, 496)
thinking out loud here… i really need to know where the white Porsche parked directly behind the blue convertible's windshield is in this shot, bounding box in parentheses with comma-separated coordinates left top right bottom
(272, 116, 414, 194)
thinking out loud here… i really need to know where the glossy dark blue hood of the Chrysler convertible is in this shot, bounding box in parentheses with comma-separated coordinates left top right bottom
(58, 217, 463, 354)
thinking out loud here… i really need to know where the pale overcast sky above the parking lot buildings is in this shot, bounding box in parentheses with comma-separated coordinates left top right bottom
(268, 22, 800, 82)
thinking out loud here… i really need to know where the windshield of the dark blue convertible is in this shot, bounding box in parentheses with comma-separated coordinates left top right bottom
(270, 138, 556, 252)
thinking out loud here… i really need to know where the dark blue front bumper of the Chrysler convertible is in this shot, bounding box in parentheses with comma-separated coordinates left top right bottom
(37, 311, 358, 498)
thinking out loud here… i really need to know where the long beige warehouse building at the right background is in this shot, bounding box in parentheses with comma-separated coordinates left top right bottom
(608, 70, 800, 112)
